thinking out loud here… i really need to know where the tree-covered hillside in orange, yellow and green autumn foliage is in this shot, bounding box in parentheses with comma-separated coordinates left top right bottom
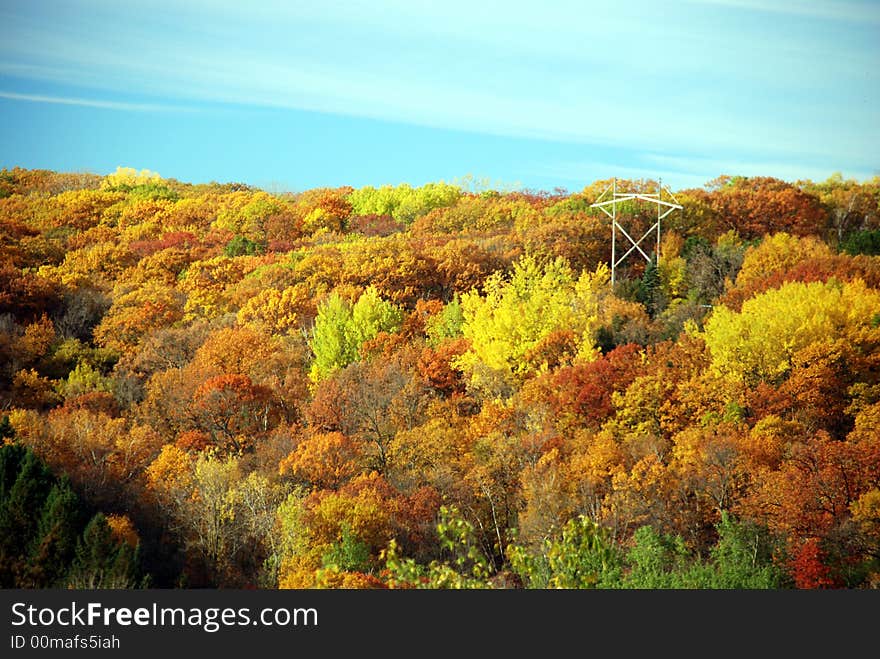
(0, 168, 880, 588)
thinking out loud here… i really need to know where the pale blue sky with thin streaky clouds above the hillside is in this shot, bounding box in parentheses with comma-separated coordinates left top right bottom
(0, 0, 880, 191)
